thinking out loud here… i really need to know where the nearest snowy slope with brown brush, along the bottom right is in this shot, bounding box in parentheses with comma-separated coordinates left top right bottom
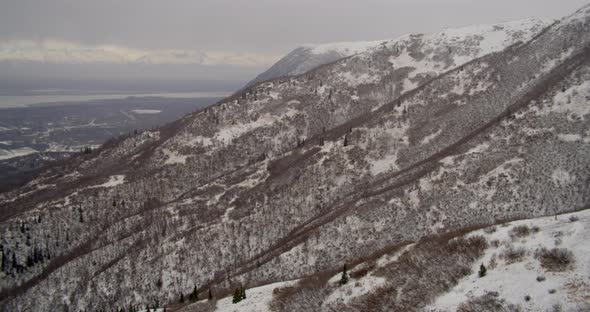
(198, 210, 590, 312)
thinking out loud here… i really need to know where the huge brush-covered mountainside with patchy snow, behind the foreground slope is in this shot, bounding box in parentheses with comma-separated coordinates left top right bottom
(0, 7, 590, 311)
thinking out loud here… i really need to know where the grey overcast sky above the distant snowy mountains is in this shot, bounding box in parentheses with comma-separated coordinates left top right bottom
(0, 0, 589, 65)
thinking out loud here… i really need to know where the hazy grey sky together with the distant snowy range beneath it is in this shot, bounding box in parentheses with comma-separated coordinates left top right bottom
(0, 0, 587, 93)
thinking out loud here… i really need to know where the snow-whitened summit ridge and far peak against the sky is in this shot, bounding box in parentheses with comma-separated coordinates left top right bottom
(247, 18, 554, 86)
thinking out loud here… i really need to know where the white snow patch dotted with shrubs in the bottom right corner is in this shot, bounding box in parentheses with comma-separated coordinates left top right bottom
(425, 210, 590, 311)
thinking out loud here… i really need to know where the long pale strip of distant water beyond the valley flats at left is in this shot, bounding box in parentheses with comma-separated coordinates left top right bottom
(0, 92, 231, 108)
